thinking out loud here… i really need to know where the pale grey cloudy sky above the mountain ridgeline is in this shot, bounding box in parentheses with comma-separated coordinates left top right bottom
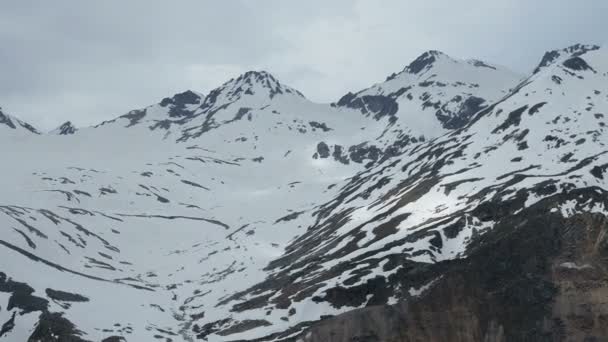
(0, 0, 608, 129)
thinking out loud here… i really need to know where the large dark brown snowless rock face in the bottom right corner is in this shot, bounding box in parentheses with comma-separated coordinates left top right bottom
(292, 189, 608, 342)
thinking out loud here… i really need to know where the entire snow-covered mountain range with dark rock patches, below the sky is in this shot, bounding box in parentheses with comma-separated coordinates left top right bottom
(0, 45, 608, 342)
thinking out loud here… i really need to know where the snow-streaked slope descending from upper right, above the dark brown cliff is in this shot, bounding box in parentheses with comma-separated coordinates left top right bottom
(186, 44, 608, 340)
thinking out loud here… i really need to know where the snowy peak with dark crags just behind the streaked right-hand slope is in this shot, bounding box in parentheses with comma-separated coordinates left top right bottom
(334, 50, 524, 138)
